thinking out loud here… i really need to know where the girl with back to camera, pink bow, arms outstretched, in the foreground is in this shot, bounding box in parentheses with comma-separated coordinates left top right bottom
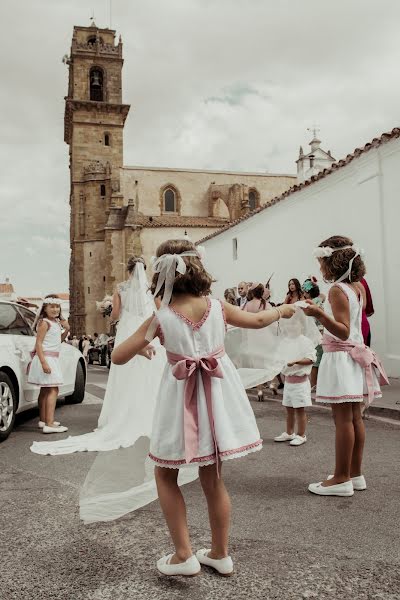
(112, 240, 295, 576)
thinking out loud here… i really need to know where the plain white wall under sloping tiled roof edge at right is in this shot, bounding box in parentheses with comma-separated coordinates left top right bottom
(204, 139, 400, 377)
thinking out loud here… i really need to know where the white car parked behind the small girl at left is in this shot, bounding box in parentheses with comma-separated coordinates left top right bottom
(0, 300, 86, 442)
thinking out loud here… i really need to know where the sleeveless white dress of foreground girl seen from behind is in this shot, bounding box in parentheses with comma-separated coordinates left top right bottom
(149, 298, 262, 468)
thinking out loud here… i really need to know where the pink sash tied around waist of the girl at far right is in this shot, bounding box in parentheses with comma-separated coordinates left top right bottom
(322, 333, 389, 406)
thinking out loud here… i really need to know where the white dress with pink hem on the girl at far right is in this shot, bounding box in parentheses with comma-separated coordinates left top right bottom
(316, 283, 382, 404)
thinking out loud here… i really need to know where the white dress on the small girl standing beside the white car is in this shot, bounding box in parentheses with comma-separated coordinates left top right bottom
(28, 319, 63, 387)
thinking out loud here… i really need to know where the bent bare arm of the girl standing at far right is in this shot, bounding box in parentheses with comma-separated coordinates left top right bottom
(302, 285, 350, 341)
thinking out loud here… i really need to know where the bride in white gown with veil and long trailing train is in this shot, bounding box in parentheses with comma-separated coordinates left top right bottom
(31, 256, 166, 455)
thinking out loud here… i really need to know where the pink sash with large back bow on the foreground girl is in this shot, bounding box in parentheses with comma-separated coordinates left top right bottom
(167, 346, 225, 475)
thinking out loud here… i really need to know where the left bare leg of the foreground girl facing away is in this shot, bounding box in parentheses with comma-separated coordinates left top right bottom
(155, 467, 193, 564)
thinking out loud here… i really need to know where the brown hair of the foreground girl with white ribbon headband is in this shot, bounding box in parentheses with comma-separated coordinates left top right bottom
(150, 240, 214, 296)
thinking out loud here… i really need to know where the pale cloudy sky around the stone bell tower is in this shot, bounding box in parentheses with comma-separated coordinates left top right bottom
(0, 0, 400, 295)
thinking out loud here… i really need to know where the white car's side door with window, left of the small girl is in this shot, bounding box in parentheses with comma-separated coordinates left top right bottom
(0, 302, 38, 407)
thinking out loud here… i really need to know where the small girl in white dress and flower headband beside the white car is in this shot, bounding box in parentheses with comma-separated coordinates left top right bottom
(28, 296, 69, 433)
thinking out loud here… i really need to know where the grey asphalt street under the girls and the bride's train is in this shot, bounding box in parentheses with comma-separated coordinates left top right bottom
(0, 367, 400, 600)
